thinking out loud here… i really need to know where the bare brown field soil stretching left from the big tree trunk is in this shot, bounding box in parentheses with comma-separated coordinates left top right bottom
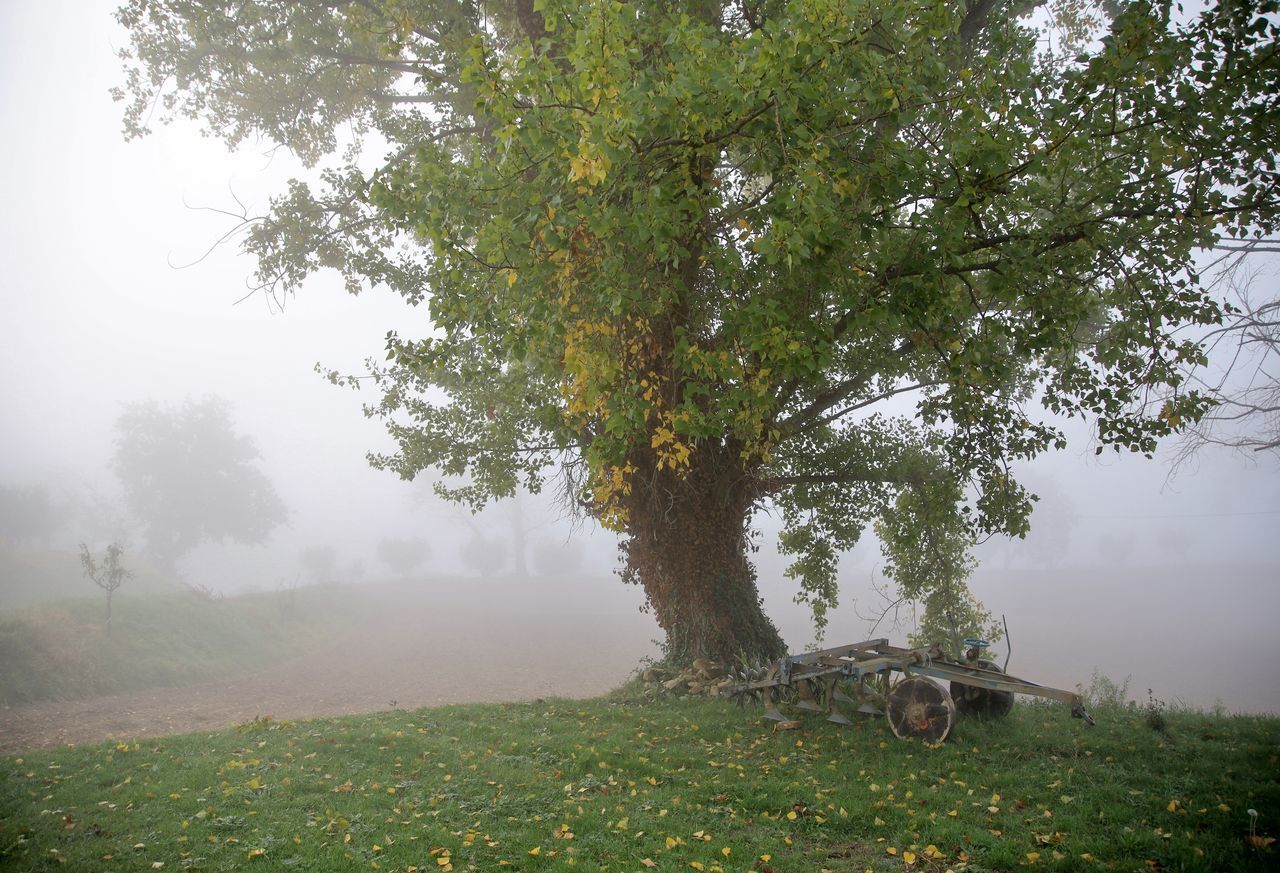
(0, 582, 655, 754)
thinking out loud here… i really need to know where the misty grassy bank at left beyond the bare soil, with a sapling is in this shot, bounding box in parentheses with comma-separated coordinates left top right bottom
(0, 586, 371, 705)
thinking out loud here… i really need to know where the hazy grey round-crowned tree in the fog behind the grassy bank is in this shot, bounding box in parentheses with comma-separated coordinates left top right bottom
(113, 397, 288, 571)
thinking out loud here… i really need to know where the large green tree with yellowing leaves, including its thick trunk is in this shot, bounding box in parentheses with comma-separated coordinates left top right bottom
(119, 0, 1280, 659)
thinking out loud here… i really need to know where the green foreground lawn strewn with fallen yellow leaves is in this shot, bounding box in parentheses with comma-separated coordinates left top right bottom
(0, 691, 1280, 873)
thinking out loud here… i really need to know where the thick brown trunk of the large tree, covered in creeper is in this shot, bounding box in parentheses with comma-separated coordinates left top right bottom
(622, 443, 786, 664)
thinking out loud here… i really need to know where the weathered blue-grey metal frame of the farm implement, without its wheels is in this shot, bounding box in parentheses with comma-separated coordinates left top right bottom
(721, 637, 1093, 725)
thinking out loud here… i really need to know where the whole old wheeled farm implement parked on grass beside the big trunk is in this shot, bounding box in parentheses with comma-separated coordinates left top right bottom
(721, 639, 1093, 742)
